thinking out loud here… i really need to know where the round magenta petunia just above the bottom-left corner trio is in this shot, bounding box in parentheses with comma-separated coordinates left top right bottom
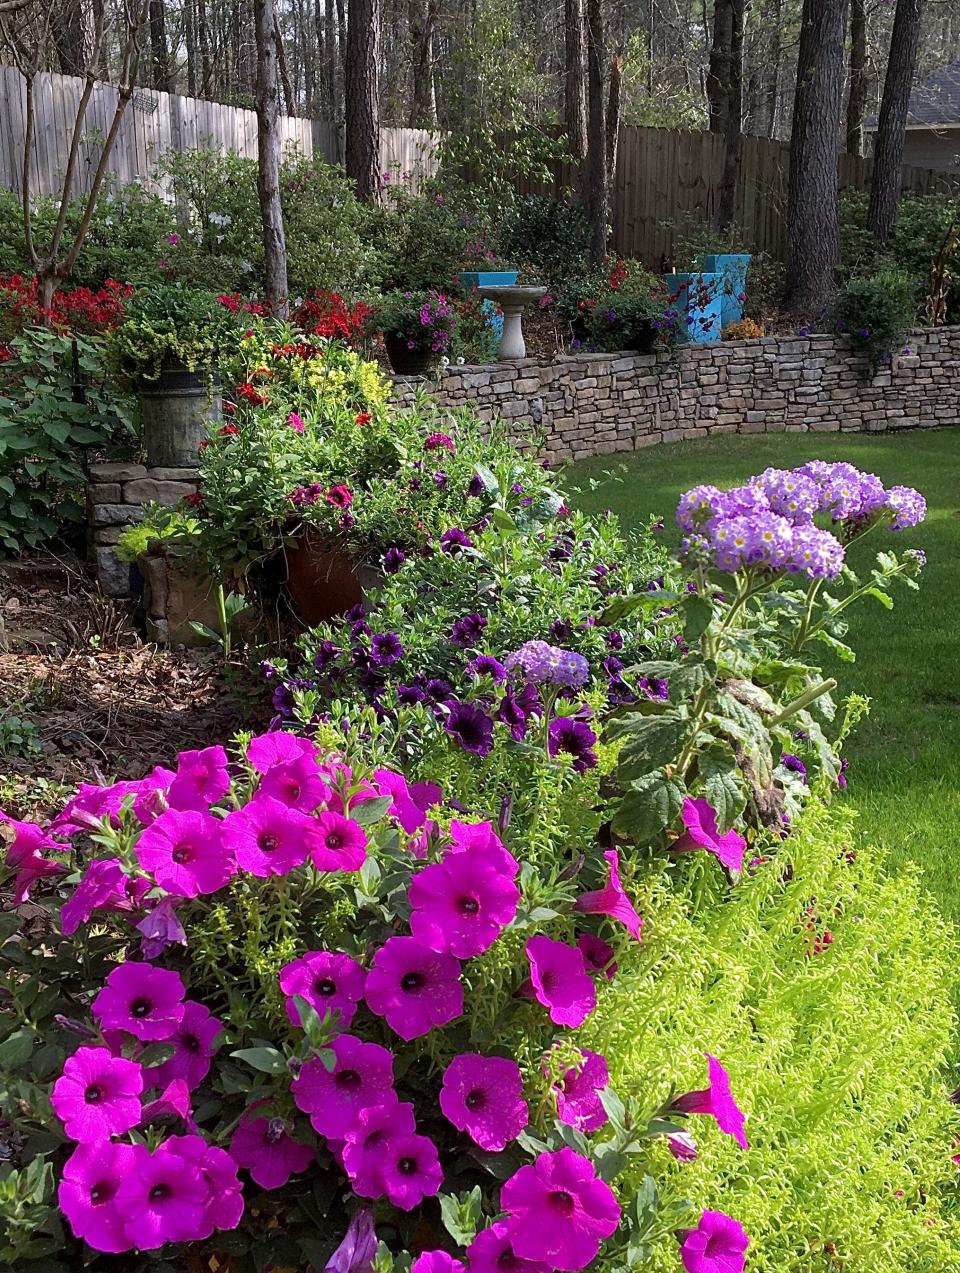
(50, 1048, 144, 1144)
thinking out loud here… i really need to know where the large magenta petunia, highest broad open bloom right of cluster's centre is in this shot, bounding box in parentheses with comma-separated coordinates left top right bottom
(407, 849, 519, 959)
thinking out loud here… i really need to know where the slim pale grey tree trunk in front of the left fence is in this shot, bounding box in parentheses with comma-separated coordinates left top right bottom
(253, 0, 288, 318)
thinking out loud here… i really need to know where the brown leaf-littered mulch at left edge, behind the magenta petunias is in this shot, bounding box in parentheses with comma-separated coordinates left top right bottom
(0, 552, 254, 816)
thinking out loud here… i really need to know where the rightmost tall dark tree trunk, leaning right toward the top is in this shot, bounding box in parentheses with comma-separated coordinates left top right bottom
(867, 0, 923, 243)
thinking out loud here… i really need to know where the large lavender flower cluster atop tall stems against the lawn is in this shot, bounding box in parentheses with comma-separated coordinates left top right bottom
(676, 460, 927, 579)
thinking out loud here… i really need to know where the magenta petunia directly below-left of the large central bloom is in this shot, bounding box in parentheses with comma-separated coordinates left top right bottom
(367, 937, 463, 1043)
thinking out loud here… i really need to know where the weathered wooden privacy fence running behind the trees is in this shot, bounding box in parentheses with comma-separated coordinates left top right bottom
(0, 66, 960, 269)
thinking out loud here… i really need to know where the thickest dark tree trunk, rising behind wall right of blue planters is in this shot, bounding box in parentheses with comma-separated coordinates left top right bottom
(787, 0, 847, 313)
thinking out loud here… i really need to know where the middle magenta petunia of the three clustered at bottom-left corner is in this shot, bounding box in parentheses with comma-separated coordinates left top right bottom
(117, 1144, 210, 1251)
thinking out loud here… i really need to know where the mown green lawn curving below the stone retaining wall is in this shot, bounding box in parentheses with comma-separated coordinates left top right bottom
(570, 429, 960, 922)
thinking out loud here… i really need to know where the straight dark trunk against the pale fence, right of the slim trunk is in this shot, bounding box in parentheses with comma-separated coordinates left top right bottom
(344, 0, 379, 204)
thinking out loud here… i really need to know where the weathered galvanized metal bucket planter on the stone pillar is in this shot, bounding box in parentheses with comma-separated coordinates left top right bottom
(139, 367, 223, 468)
